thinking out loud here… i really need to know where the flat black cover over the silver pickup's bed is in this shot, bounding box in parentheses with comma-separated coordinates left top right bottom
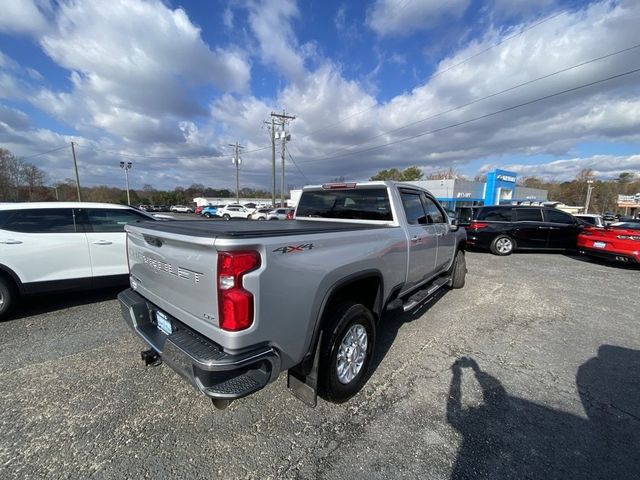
(136, 220, 392, 238)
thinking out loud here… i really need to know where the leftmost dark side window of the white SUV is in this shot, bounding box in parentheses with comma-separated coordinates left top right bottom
(3, 208, 77, 233)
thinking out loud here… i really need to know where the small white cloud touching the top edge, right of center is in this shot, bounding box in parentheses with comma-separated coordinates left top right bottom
(366, 0, 469, 37)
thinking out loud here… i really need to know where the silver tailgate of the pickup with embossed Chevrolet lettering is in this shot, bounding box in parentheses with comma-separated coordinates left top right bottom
(126, 225, 218, 331)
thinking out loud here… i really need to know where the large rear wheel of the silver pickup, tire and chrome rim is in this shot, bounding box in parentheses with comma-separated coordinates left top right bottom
(318, 301, 376, 403)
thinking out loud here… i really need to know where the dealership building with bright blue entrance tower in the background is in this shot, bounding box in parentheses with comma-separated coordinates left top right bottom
(407, 169, 547, 210)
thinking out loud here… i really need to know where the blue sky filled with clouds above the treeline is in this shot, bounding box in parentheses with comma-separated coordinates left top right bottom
(0, 0, 640, 189)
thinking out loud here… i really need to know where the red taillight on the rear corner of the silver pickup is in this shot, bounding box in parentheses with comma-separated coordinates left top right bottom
(218, 250, 260, 332)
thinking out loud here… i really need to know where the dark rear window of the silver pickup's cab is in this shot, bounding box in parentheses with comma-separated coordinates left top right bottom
(296, 187, 393, 220)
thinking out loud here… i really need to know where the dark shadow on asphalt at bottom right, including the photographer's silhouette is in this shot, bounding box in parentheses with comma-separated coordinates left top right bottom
(447, 345, 640, 480)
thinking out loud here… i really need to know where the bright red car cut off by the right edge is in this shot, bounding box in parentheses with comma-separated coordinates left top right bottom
(578, 222, 640, 263)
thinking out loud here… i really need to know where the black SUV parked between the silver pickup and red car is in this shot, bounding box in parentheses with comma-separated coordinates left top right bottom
(466, 205, 584, 255)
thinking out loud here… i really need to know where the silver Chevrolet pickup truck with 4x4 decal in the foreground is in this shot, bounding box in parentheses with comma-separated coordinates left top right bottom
(118, 182, 466, 408)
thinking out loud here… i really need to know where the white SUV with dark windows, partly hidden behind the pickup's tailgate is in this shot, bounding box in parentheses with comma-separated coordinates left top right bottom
(0, 202, 157, 317)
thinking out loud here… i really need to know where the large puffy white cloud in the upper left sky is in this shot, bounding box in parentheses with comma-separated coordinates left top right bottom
(28, 0, 250, 143)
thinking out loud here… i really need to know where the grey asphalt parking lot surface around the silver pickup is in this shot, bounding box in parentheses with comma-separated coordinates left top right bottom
(0, 252, 640, 479)
